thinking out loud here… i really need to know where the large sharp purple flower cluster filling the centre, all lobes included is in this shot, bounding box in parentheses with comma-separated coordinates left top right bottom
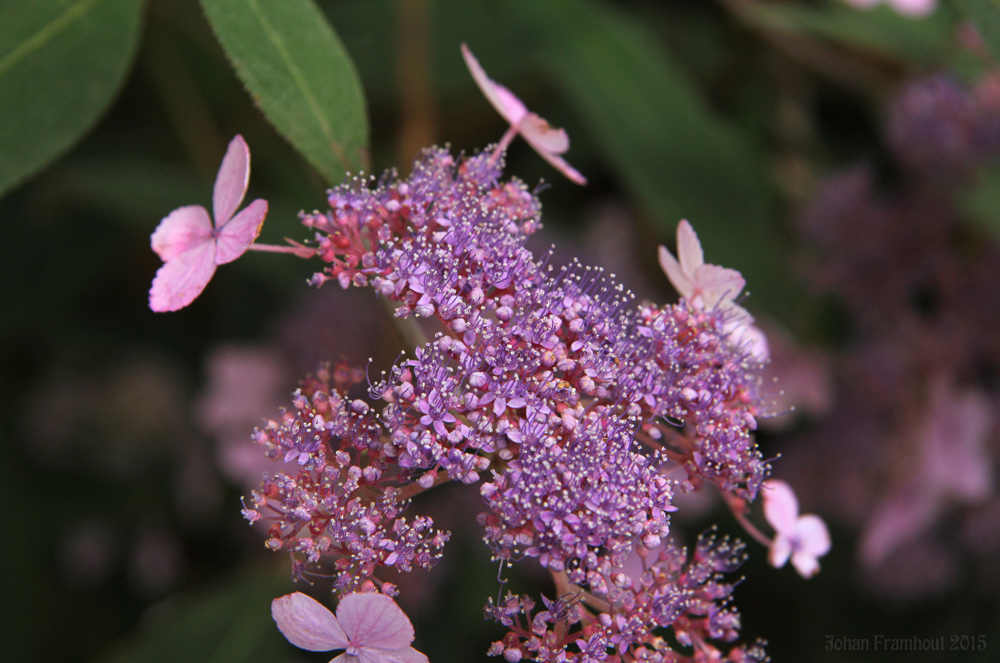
(247, 149, 769, 660)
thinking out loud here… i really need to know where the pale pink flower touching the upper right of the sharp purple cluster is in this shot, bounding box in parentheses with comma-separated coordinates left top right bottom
(659, 219, 769, 361)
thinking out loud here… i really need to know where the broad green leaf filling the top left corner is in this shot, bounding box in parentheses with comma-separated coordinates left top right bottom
(0, 0, 143, 195)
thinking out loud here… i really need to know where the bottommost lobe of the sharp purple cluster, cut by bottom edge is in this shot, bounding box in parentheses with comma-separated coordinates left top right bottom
(486, 531, 768, 663)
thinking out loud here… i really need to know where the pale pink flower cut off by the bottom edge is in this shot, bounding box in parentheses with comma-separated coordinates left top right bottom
(271, 592, 427, 663)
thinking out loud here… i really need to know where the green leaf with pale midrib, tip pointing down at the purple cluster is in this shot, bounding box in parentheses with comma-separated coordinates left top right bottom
(201, 0, 368, 184)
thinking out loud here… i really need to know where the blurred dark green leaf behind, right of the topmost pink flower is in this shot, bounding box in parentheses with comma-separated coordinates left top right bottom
(508, 0, 770, 282)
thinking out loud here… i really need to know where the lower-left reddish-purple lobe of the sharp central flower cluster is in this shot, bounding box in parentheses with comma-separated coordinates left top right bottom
(243, 370, 449, 592)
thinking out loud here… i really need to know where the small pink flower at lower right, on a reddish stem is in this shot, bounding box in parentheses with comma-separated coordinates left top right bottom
(763, 479, 830, 578)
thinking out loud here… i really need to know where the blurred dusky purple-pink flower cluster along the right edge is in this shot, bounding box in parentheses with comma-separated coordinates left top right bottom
(784, 75, 1000, 597)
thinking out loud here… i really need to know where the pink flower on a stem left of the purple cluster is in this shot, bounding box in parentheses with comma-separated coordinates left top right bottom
(149, 135, 267, 313)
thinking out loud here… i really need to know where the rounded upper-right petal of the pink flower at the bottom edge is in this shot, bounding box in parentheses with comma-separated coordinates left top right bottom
(337, 593, 414, 649)
